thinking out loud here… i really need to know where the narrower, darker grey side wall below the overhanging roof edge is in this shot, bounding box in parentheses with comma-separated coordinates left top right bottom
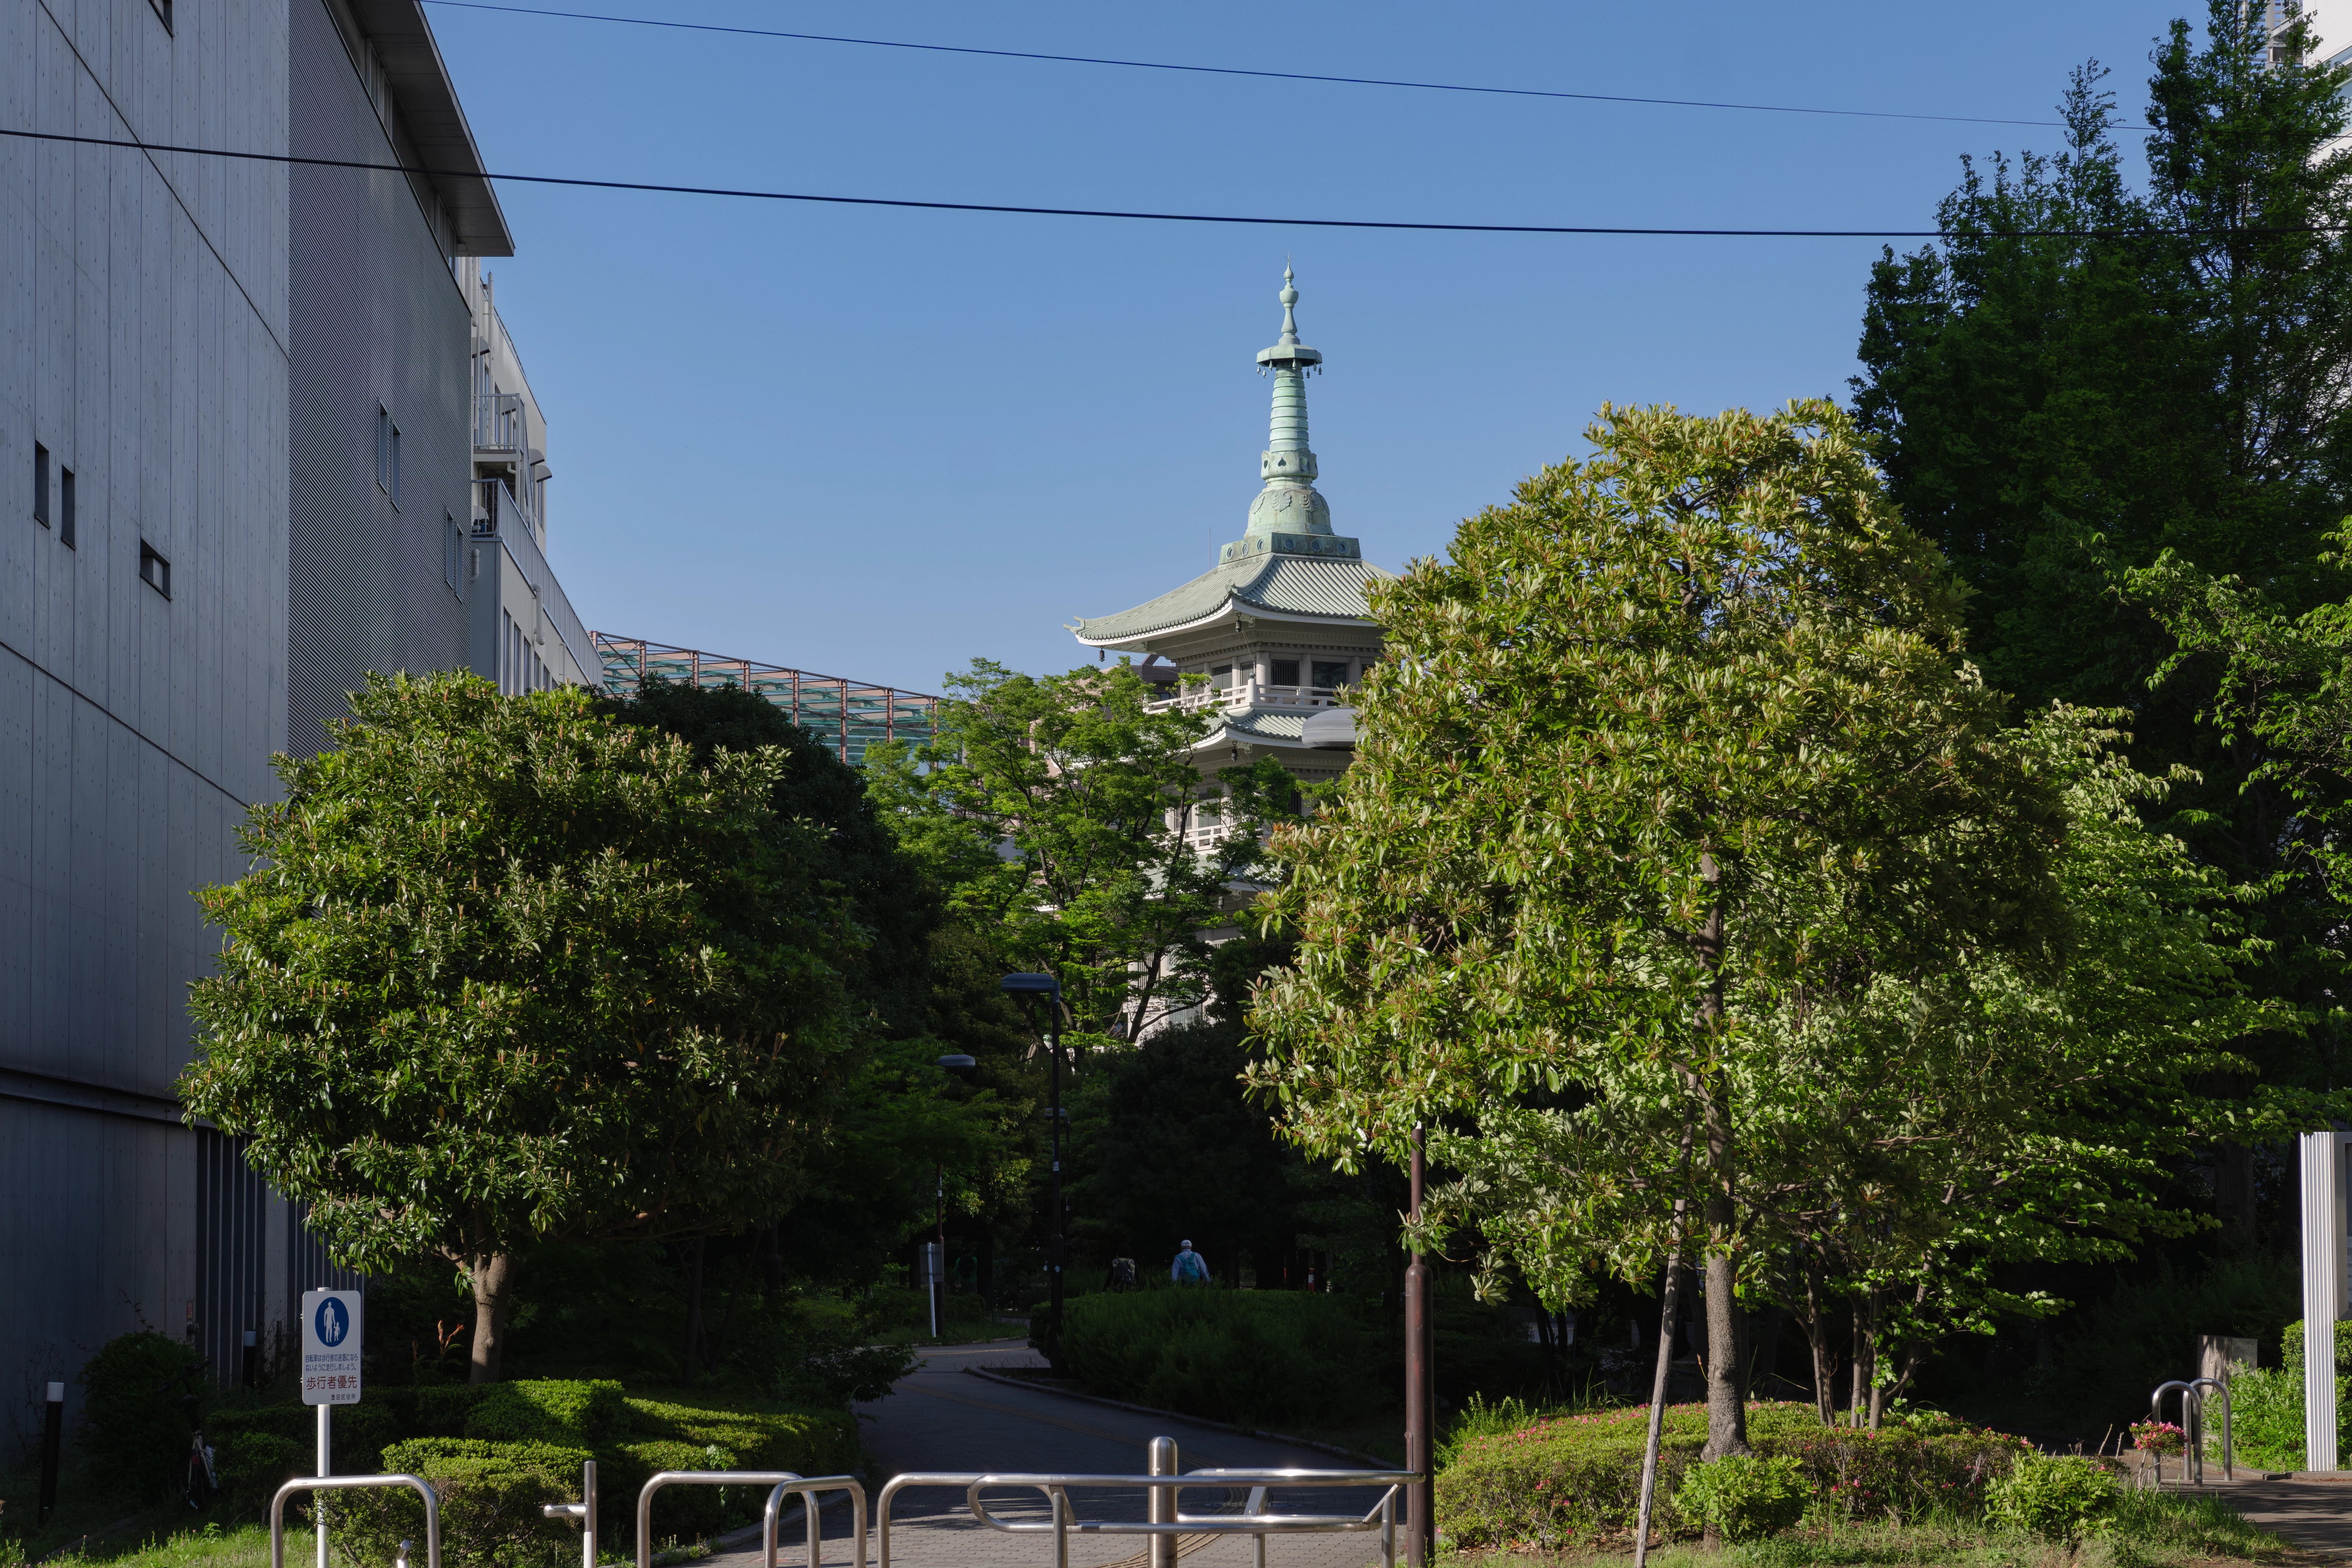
(287, 0, 473, 755)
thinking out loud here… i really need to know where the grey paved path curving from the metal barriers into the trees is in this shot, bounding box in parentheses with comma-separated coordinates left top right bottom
(706, 1340, 1402, 1568)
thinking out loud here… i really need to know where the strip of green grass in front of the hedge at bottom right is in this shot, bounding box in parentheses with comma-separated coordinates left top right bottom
(1446, 1493, 2296, 1568)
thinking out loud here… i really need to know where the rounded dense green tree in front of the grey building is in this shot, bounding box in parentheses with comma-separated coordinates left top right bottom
(181, 675, 863, 1382)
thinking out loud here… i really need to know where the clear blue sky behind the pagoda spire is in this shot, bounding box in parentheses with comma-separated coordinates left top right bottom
(428, 0, 2201, 691)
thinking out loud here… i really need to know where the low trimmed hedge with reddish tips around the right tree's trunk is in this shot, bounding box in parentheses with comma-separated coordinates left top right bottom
(1437, 1403, 2025, 1549)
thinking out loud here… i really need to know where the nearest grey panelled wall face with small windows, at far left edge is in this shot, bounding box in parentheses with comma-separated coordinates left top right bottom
(0, 0, 289, 1425)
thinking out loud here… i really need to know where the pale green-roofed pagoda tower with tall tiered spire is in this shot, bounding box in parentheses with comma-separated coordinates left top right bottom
(1070, 268, 1390, 799)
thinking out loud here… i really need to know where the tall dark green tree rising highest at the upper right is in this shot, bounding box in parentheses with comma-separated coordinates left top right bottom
(1853, 0, 2352, 1175)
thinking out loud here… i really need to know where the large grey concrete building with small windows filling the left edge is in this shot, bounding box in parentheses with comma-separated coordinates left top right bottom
(0, 0, 595, 1422)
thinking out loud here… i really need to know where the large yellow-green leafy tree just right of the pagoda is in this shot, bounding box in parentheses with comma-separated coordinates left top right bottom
(1254, 402, 2060, 1455)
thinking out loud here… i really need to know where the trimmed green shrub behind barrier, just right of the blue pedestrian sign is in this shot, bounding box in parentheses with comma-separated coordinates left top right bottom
(329, 1436, 588, 1568)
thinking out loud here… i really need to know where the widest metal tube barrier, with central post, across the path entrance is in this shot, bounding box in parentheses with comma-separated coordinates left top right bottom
(875, 1439, 1421, 1568)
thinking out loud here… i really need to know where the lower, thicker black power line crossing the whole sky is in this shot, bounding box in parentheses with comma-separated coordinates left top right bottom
(0, 127, 2314, 240)
